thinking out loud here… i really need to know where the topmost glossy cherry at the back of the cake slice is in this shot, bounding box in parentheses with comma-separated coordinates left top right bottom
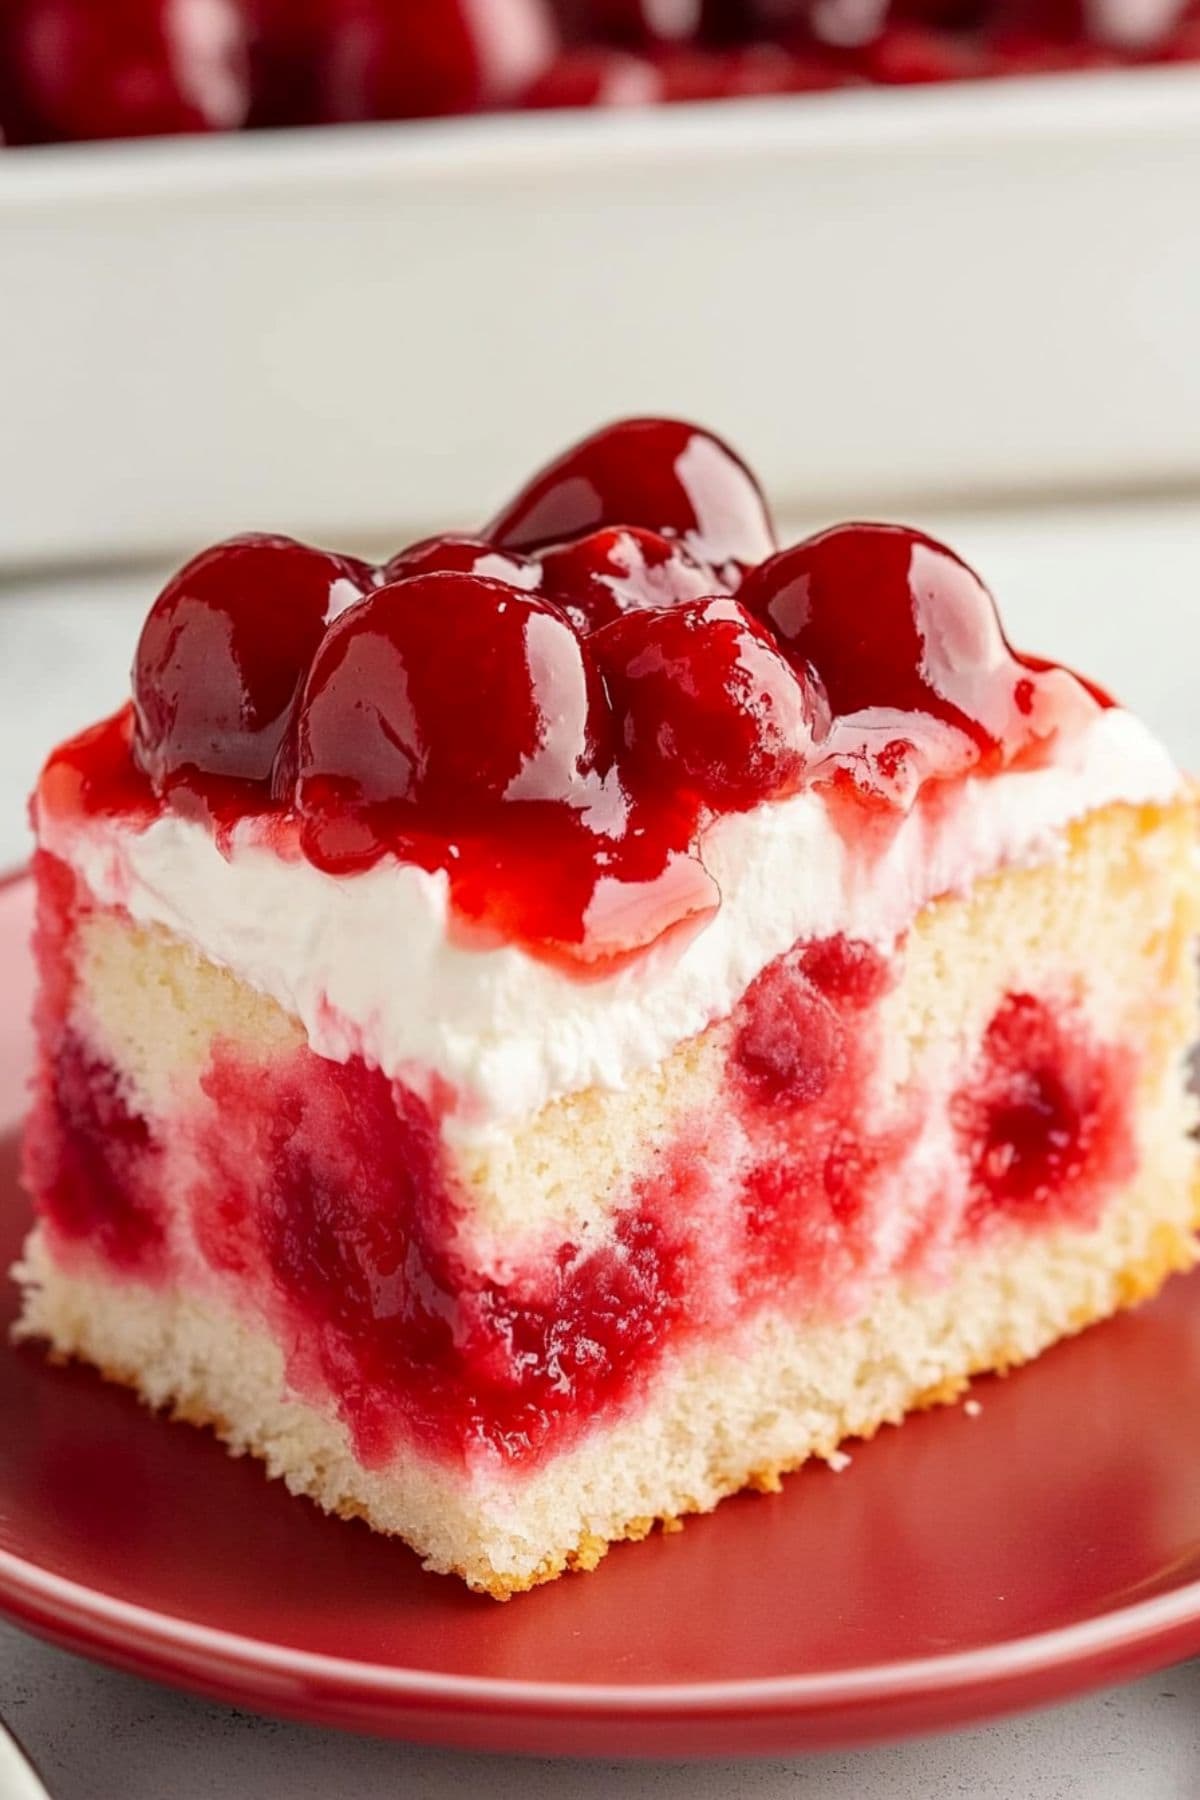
(484, 419, 775, 571)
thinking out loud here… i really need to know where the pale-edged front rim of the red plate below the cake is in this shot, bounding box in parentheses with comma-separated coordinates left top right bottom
(0, 864, 1200, 1755)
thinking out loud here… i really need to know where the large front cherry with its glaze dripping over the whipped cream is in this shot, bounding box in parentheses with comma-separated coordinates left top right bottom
(297, 574, 714, 968)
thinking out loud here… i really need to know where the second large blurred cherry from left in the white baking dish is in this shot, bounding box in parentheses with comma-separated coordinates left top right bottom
(313, 0, 558, 121)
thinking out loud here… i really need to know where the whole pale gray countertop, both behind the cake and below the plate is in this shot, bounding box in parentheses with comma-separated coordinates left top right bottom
(0, 500, 1200, 1800)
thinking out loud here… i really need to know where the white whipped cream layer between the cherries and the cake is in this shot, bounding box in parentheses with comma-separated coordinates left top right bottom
(40, 709, 1182, 1136)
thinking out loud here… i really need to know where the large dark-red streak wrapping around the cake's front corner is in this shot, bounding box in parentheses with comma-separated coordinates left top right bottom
(193, 1049, 689, 1462)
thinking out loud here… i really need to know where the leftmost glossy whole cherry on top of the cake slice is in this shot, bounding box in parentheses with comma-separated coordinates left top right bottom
(133, 536, 371, 788)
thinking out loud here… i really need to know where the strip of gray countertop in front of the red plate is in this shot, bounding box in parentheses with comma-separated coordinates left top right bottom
(0, 1625, 1200, 1800)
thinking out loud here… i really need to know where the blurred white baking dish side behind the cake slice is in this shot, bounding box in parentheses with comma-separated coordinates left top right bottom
(0, 68, 1200, 565)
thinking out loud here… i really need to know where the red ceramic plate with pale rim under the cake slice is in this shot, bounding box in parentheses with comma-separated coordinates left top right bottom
(0, 882, 1200, 1755)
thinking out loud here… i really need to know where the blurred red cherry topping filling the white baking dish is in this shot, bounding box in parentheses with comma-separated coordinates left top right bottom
(0, 0, 1200, 142)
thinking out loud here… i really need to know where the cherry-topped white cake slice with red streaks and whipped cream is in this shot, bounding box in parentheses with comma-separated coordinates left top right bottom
(16, 419, 1196, 1597)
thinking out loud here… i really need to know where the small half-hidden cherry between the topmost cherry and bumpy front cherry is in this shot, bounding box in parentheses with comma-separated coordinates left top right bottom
(540, 526, 714, 634)
